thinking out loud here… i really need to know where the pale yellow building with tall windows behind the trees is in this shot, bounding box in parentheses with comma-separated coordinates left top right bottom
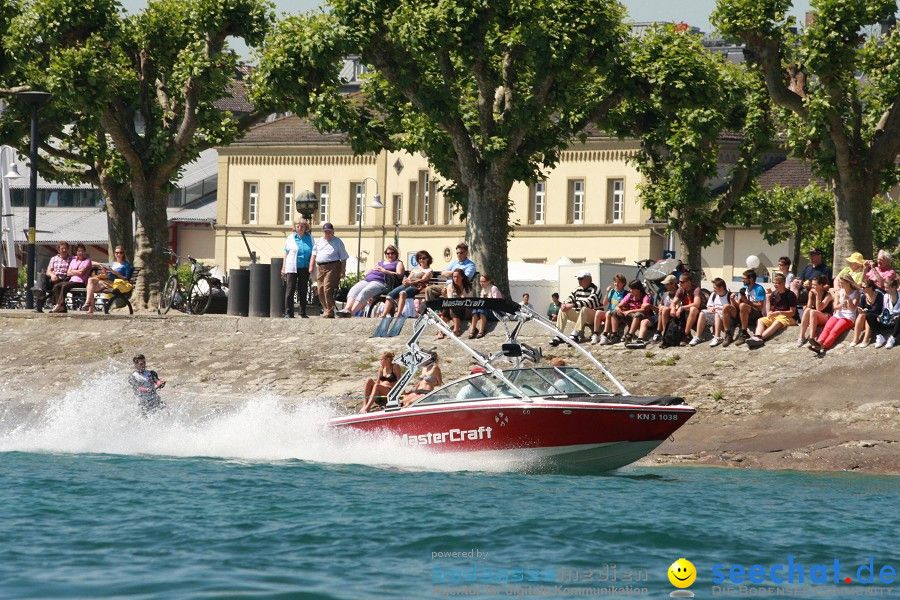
(215, 116, 790, 281)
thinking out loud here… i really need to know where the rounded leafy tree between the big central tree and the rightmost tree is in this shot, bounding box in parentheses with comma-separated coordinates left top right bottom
(609, 25, 771, 276)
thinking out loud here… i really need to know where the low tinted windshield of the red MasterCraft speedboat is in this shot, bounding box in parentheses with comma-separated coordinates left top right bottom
(416, 367, 611, 406)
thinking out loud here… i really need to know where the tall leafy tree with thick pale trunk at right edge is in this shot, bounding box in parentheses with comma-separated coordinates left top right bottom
(712, 0, 900, 258)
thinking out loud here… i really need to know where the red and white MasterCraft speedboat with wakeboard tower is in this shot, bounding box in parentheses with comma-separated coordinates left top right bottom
(329, 298, 696, 473)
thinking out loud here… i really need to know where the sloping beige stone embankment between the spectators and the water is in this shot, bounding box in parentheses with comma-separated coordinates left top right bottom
(0, 310, 900, 474)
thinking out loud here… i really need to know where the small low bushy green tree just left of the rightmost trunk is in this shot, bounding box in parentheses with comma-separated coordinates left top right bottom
(739, 183, 834, 265)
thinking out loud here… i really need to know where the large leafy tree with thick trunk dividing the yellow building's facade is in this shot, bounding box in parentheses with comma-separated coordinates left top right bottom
(255, 0, 626, 289)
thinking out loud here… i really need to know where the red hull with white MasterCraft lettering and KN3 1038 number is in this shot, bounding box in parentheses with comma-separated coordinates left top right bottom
(330, 399, 695, 473)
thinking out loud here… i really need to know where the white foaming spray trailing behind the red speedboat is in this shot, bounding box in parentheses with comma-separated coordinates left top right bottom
(0, 368, 536, 472)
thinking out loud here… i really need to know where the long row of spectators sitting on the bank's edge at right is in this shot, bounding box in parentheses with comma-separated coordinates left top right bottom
(548, 248, 900, 356)
